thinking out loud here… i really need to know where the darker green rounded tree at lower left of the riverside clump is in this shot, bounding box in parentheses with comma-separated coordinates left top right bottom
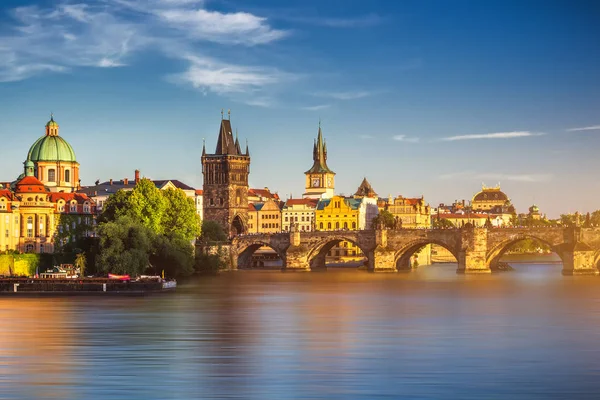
(97, 216, 154, 276)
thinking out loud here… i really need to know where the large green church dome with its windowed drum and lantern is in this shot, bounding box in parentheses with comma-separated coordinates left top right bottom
(24, 115, 79, 192)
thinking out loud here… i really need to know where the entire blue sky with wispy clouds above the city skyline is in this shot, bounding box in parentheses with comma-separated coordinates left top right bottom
(0, 0, 600, 217)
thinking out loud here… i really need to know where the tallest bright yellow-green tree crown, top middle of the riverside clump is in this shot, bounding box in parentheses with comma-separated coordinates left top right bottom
(126, 178, 167, 234)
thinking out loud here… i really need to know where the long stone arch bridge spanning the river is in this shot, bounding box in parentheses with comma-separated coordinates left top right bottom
(230, 226, 600, 275)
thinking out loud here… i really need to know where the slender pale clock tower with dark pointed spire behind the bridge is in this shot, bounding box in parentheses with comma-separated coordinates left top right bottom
(302, 122, 335, 199)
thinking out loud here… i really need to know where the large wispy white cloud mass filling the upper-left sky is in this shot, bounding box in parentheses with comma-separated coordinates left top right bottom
(0, 0, 296, 98)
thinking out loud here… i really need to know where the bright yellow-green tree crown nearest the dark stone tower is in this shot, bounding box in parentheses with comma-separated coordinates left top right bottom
(162, 189, 201, 242)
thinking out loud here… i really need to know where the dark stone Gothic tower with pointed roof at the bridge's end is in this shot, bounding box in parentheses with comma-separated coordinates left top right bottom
(202, 111, 250, 236)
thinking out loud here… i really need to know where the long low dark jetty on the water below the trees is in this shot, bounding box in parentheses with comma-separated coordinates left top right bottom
(0, 278, 177, 295)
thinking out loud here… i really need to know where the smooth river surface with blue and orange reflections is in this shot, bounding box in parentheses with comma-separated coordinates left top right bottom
(0, 264, 600, 399)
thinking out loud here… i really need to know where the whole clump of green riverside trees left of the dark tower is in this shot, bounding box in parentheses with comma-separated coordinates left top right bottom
(97, 179, 200, 276)
